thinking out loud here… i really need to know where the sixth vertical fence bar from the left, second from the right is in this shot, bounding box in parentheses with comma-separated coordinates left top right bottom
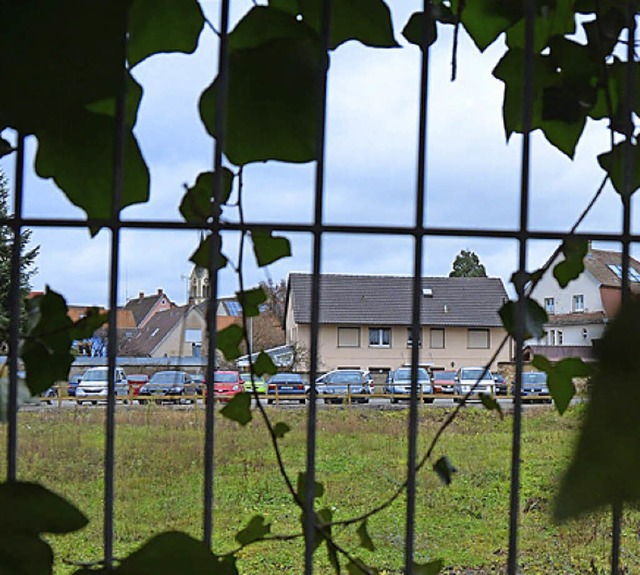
(507, 0, 536, 575)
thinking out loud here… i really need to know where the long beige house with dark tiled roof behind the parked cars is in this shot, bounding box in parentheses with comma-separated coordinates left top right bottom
(285, 273, 510, 376)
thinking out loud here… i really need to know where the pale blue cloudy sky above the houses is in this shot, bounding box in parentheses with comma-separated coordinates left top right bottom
(0, 0, 622, 305)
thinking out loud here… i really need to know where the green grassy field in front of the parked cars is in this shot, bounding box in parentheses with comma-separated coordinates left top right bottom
(0, 406, 640, 575)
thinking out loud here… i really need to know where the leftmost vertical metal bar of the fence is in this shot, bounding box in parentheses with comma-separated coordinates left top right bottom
(7, 133, 24, 481)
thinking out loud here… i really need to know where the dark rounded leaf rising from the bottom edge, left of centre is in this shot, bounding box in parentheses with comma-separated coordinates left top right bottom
(114, 531, 232, 575)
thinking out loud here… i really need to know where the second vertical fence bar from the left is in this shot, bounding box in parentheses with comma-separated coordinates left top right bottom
(103, 13, 128, 569)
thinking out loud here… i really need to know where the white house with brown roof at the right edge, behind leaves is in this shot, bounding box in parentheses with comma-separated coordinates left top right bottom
(528, 247, 640, 359)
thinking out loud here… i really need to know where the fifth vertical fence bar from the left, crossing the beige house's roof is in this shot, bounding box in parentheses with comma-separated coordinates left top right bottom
(404, 0, 431, 575)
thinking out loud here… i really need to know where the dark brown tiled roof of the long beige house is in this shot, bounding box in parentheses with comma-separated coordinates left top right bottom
(287, 273, 508, 327)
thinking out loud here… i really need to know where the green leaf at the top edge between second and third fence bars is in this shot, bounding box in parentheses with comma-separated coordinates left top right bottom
(127, 0, 204, 67)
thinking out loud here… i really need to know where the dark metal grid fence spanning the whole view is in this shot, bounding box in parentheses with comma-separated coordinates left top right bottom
(5, 0, 635, 575)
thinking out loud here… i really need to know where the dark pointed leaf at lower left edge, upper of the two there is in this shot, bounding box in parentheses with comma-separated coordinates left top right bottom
(0, 482, 88, 539)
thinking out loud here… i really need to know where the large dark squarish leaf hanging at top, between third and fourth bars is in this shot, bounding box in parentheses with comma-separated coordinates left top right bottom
(200, 9, 327, 166)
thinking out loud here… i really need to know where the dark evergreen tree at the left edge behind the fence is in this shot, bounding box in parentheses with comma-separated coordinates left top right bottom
(0, 170, 40, 347)
